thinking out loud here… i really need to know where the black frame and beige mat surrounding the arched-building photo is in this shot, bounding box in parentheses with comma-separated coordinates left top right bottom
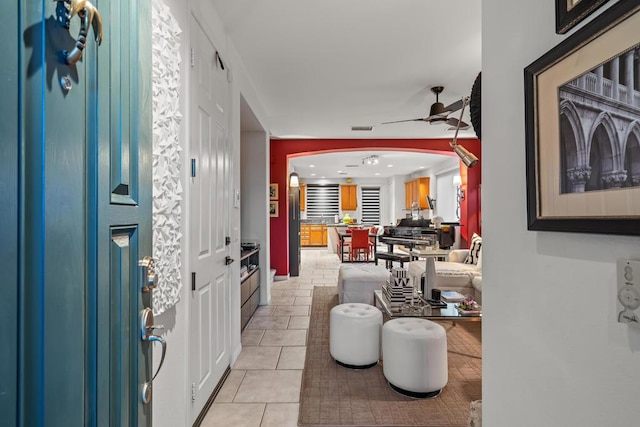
(524, 0, 640, 235)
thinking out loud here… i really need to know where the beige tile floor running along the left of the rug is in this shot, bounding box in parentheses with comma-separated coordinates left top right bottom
(202, 249, 340, 427)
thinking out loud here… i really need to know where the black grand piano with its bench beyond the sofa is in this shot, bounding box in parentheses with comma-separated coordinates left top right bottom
(376, 218, 455, 269)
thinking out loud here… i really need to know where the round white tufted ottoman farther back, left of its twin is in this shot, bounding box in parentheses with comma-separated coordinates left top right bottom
(329, 303, 382, 369)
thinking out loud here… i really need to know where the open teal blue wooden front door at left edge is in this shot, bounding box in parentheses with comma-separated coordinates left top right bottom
(0, 0, 151, 427)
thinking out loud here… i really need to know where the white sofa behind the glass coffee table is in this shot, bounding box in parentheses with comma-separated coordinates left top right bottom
(408, 249, 482, 303)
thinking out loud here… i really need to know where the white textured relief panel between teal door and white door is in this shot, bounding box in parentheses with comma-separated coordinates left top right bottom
(151, 0, 184, 315)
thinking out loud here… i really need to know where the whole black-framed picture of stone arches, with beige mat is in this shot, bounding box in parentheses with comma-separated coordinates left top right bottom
(525, 0, 640, 235)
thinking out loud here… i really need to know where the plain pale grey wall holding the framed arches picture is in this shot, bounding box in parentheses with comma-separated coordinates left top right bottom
(482, 0, 640, 427)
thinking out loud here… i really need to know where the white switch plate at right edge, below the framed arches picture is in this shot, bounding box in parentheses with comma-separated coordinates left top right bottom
(617, 259, 640, 327)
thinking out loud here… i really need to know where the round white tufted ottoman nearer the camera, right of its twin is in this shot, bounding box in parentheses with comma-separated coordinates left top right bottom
(382, 317, 449, 398)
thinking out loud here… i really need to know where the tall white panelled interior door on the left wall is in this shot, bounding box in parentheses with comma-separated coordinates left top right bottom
(189, 17, 231, 421)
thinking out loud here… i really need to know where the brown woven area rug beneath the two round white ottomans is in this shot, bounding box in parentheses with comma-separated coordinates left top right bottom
(298, 286, 482, 427)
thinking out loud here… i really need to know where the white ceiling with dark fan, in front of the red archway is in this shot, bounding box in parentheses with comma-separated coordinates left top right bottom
(211, 0, 481, 173)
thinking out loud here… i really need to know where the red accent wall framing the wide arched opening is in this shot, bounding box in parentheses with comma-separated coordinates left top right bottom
(270, 139, 482, 276)
